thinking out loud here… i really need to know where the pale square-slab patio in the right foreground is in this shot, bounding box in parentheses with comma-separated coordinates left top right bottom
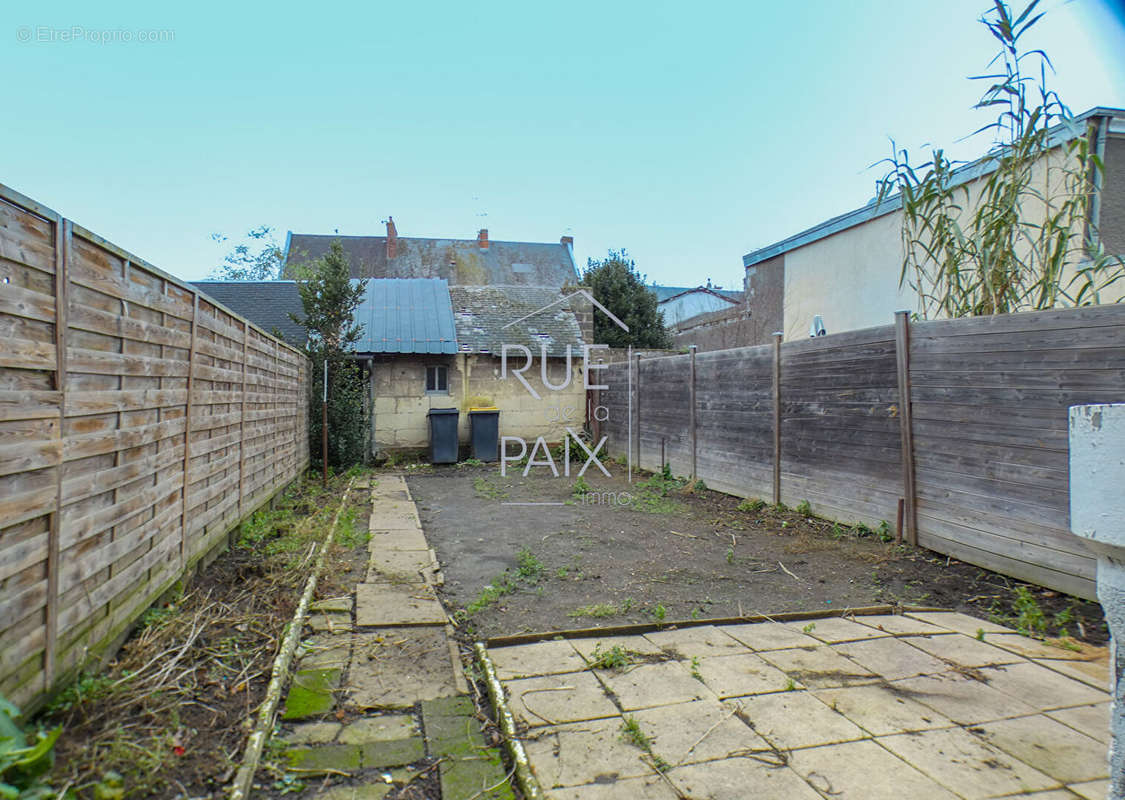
(489, 612, 1109, 800)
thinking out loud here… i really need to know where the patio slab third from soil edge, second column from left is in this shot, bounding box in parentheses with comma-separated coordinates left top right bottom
(630, 700, 770, 766)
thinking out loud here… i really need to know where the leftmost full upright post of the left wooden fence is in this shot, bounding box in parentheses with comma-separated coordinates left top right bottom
(43, 217, 71, 689)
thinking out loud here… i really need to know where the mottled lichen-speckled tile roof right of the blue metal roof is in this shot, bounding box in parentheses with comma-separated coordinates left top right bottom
(449, 286, 586, 356)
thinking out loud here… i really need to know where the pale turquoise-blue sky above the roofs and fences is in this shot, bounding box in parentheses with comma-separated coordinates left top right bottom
(0, 0, 1125, 286)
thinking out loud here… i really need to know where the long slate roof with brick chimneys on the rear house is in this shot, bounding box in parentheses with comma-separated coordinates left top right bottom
(281, 233, 578, 287)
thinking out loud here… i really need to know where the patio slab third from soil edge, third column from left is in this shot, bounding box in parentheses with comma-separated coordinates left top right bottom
(741, 692, 867, 749)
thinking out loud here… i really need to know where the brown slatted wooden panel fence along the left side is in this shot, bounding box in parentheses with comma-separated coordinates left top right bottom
(0, 186, 308, 705)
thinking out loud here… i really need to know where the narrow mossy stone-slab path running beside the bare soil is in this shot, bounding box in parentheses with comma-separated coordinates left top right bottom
(276, 476, 513, 800)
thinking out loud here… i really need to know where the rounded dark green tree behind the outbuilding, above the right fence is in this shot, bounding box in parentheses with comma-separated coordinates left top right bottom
(583, 249, 672, 348)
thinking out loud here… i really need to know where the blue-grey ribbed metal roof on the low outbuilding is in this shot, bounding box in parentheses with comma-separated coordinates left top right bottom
(353, 278, 457, 353)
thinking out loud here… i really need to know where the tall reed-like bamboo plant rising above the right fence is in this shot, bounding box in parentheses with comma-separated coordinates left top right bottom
(879, 0, 1125, 317)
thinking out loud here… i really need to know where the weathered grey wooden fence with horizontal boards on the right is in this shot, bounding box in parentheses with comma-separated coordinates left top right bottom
(596, 305, 1125, 599)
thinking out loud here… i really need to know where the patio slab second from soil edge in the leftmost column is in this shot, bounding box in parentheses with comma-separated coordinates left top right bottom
(504, 672, 618, 727)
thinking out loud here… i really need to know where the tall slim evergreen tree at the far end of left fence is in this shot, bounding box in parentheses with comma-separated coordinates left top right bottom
(289, 241, 370, 469)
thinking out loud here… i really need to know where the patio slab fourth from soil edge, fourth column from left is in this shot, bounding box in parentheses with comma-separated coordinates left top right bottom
(879, 728, 1059, 800)
